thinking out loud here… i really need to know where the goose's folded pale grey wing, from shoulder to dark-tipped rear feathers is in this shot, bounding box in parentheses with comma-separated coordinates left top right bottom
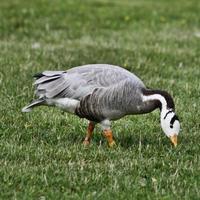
(34, 64, 143, 100)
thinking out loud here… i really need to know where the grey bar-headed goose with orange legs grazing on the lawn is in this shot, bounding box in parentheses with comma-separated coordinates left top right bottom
(22, 64, 180, 146)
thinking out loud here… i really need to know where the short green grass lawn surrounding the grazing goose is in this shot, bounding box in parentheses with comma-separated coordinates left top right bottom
(0, 0, 200, 200)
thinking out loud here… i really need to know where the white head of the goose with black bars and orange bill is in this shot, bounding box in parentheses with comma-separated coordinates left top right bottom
(161, 109, 180, 146)
